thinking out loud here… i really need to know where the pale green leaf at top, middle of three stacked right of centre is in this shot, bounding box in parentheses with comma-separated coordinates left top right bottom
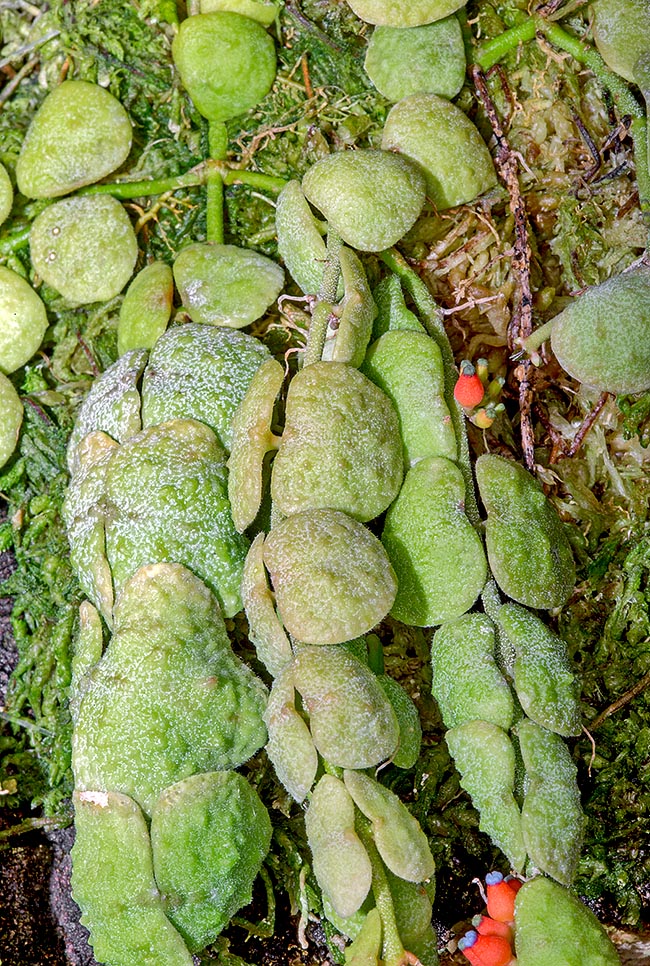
(364, 16, 466, 101)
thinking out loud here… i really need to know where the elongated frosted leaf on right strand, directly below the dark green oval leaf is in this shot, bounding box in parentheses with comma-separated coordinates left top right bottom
(497, 604, 582, 737)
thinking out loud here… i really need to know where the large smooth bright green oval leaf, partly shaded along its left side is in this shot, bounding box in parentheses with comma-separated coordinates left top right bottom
(381, 456, 487, 627)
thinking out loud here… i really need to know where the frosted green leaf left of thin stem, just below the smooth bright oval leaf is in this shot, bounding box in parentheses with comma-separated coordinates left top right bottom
(431, 614, 514, 731)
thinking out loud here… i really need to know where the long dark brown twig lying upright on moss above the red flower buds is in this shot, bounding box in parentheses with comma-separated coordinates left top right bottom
(471, 65, 535, 470)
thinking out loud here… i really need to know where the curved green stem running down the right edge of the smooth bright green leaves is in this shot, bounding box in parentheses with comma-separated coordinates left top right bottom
(379, 248, 482, 533)
